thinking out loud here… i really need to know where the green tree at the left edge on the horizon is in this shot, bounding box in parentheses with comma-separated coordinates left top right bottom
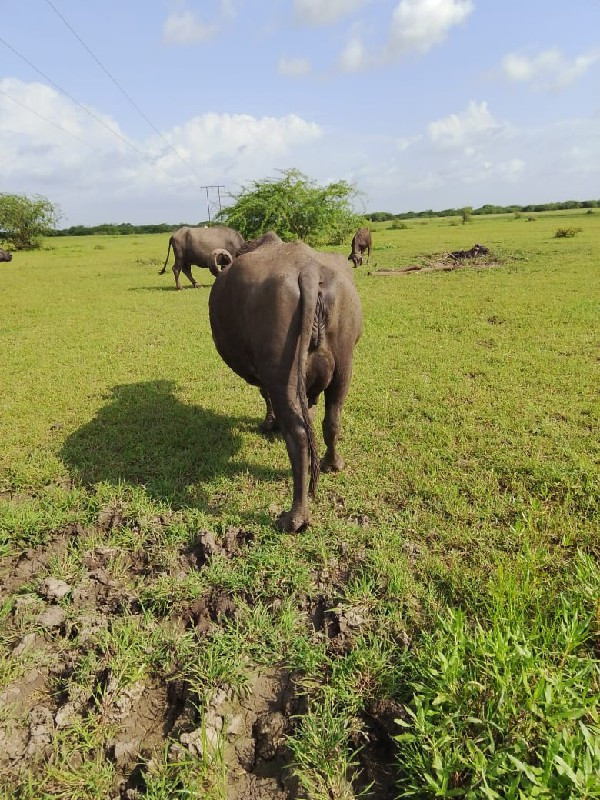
(0, 193, 61, 250)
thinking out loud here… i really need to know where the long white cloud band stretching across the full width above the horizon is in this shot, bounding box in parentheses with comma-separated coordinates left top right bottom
(0, 79, 600, 225)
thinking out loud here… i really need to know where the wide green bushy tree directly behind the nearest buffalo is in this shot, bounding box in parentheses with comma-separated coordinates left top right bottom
(217, 169, 361, 245)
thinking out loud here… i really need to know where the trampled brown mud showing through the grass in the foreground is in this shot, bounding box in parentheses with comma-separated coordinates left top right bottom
(0, 509, 402, 800)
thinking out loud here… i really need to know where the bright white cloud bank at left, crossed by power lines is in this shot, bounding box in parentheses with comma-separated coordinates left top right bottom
(0, 79, 323, 225)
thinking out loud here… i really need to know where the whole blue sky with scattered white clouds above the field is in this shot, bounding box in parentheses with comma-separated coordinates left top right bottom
(0, 0, 600, 225)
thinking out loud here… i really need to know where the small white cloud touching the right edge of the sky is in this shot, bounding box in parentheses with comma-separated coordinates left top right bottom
(501, 48, 600, 90)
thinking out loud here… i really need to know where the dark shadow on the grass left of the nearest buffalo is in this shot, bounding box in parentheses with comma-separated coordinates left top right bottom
(61, 381, 283, 512)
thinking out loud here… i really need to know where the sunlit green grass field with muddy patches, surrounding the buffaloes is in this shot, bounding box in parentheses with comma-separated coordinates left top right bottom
(0, 212, 600, 800)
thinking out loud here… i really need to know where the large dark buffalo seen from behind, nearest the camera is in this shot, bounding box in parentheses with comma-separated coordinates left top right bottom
(209, 233, 362, 531)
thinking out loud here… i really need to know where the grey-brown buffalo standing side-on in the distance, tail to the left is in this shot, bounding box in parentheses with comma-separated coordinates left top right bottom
(158, 226, 244, 289)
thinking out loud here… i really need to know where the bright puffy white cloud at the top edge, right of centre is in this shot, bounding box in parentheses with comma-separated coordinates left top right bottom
(386, 0, 473, 60)
